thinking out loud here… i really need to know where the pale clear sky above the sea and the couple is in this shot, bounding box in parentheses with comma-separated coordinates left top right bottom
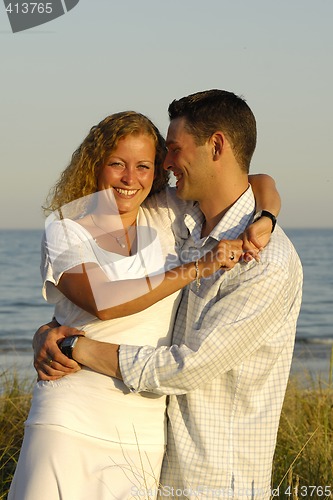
(0, 0, 333, 228)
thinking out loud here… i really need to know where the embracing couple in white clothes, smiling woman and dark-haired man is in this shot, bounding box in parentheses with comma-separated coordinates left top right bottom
(8, 90, 302, 500)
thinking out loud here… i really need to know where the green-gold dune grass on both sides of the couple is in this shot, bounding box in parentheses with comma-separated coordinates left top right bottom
(0, 366, 333, 500)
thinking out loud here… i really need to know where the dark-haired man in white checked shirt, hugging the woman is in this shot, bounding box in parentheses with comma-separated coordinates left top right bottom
(33, 90, 302, 499)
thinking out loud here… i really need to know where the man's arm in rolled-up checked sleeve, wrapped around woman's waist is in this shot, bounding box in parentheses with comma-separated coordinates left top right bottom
(68, 248, 297, 394)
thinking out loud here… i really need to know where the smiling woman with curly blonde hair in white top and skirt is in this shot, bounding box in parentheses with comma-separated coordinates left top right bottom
(8, 112, 278, 500)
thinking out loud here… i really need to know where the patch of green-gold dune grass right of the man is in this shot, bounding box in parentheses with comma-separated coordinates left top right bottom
(272, 378, 333, 499)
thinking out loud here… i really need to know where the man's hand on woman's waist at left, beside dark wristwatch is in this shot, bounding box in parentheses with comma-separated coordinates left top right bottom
(32, 321, 84, 380)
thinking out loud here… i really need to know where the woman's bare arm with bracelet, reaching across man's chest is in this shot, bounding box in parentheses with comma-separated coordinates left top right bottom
(57, 240, 243, 320)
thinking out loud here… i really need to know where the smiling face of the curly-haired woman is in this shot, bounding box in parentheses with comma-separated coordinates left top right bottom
(97, 134, 156, 214)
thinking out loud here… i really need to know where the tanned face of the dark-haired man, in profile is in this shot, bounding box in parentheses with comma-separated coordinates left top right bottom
(164, 118, 212, 201)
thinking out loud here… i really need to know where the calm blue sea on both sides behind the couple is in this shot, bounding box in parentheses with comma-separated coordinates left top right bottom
(0, 228, 333, 383)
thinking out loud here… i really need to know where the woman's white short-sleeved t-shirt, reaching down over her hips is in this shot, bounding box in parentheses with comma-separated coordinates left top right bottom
(27, 190, 187, 444)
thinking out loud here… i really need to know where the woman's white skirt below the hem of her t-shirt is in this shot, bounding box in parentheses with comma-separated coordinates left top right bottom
(8, 425, 165, 500)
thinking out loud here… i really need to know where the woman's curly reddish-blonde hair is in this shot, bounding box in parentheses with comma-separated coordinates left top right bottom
(43, 111, 169, 215)
